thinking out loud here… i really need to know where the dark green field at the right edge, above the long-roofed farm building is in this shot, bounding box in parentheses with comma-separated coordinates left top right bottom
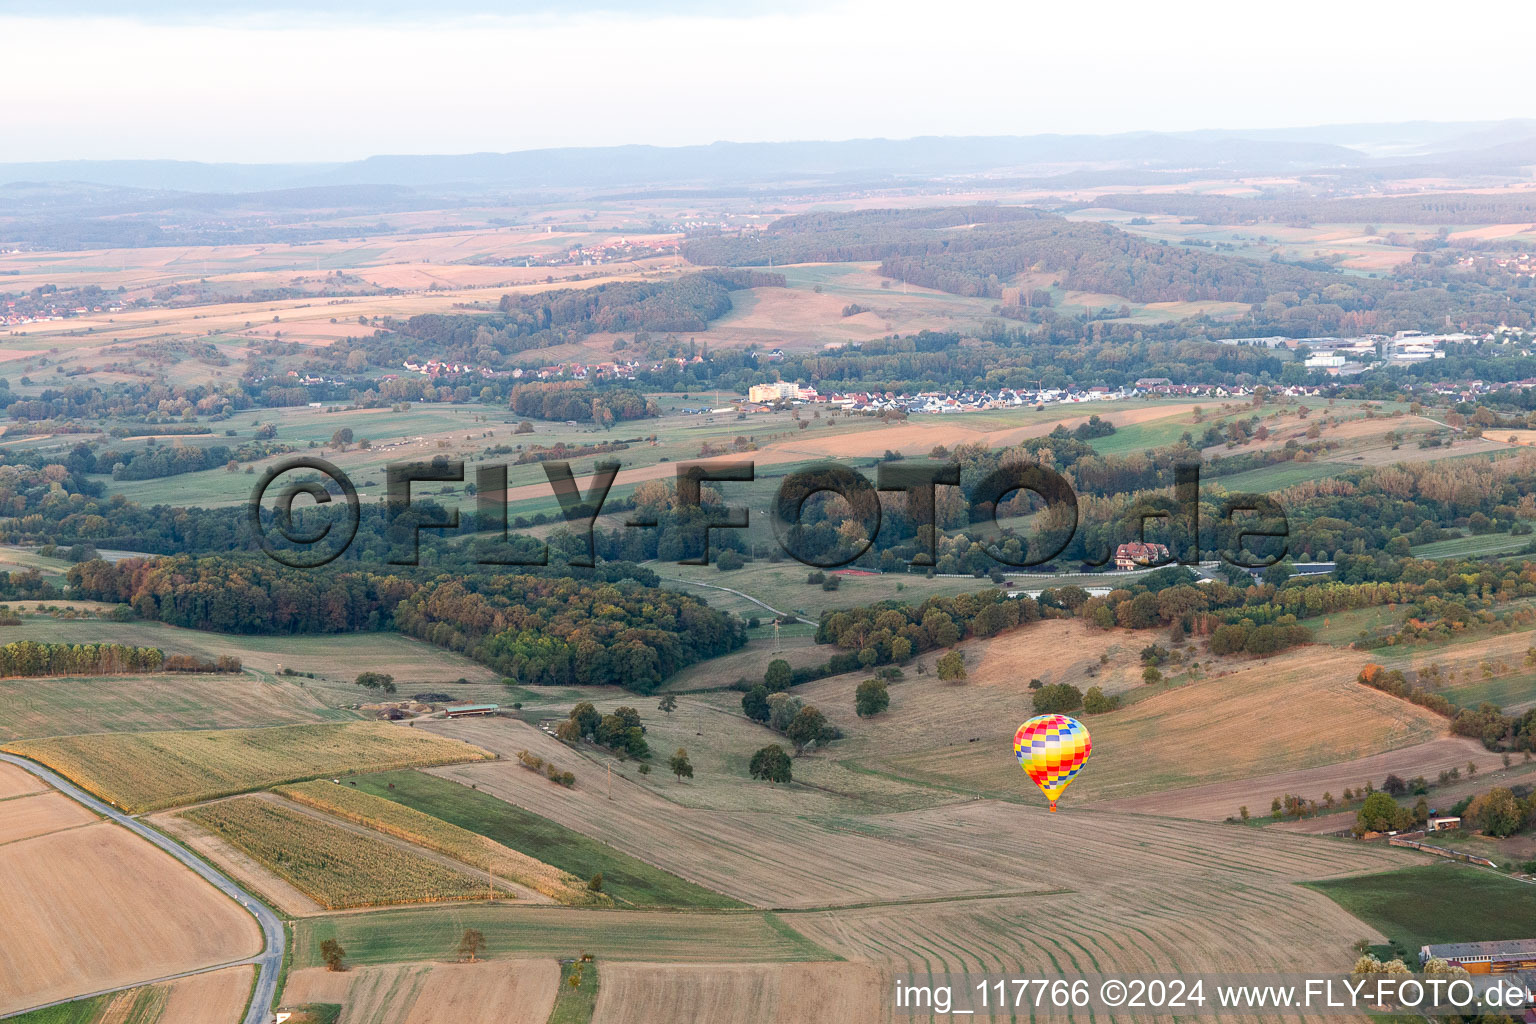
(1310, 863, 1536, 950)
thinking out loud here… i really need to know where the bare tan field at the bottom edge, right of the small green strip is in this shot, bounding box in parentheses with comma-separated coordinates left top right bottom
(591, 963, 889, 1024)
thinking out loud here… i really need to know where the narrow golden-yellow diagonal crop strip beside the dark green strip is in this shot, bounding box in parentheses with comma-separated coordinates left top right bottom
(276, 781, 592, 906)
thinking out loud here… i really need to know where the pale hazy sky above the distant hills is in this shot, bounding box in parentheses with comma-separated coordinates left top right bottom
(0, 0, 1536, 163)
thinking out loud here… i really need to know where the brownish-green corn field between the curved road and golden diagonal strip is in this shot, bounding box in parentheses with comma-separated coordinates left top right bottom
(183, 797, 488, 910)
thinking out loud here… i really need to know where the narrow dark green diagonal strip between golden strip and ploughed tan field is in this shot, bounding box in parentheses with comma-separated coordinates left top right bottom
(356, 772, 746, 907)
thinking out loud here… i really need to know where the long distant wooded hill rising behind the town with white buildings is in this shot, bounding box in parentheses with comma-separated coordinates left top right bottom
(684, 206, 1351, 304)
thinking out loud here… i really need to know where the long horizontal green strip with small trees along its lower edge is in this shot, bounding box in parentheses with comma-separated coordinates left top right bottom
(293, 904, 837, 967)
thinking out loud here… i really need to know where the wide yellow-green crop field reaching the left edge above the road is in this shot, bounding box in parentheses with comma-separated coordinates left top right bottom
(5, 722, 488, 814)
